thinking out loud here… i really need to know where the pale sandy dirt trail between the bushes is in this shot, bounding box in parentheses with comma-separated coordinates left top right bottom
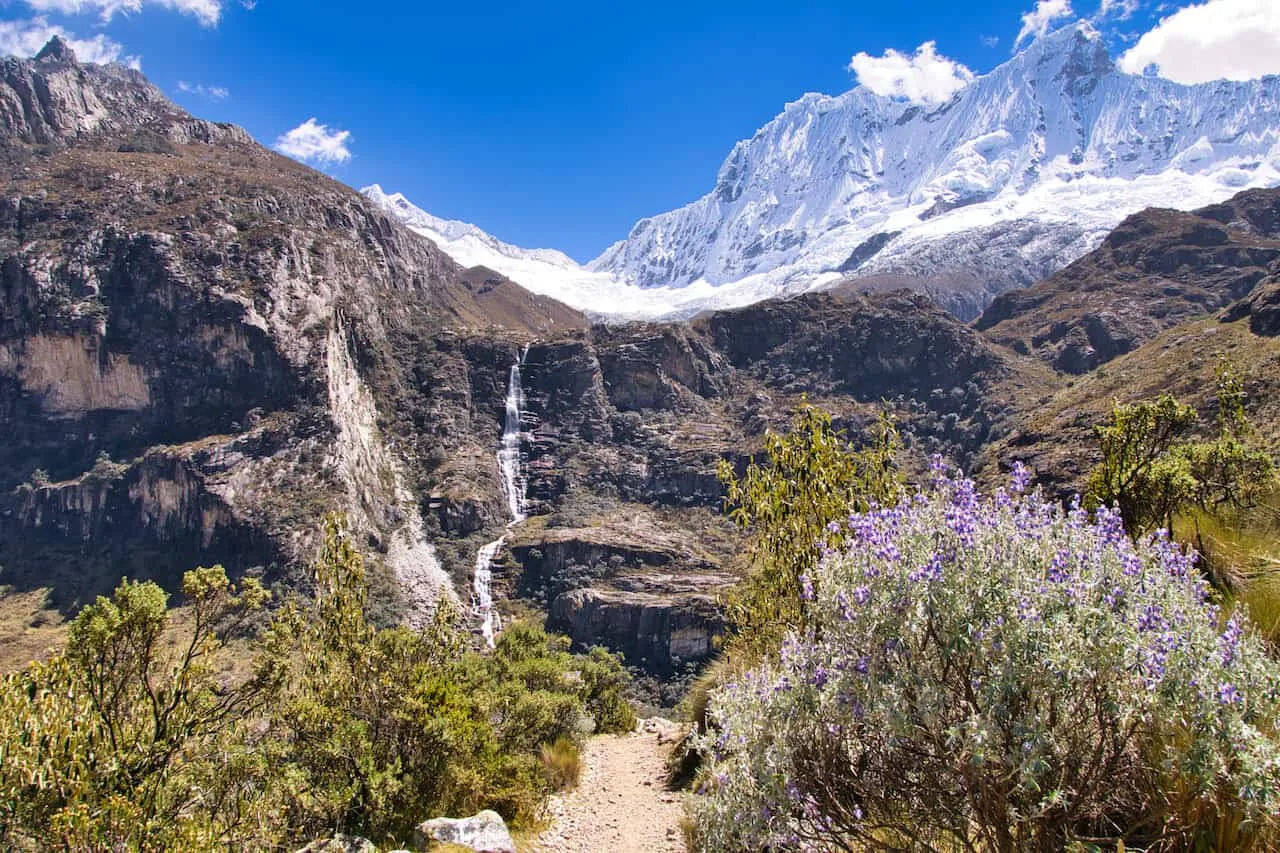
(532, 720, 685, 853)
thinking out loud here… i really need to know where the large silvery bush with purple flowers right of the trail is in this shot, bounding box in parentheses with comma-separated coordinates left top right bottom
(692, 466, 1280, 852)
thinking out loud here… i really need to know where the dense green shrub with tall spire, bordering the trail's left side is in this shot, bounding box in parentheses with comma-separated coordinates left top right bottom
(274, 519, 625, 843)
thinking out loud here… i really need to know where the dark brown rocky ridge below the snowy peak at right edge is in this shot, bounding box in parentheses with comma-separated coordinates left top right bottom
(975, 190, 1280, 374)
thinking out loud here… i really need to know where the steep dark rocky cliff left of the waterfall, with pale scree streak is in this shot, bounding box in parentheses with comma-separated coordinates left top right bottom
(0, 42, 581, 613)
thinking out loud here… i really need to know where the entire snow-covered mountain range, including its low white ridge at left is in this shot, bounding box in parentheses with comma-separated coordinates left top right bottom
(366, 23, 1280, 318)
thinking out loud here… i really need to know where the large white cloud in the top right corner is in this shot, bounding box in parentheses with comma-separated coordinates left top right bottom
(1120, 0, 1280, 83)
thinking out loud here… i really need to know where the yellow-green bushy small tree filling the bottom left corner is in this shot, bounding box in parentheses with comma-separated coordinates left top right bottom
(0, 566, 283, 850)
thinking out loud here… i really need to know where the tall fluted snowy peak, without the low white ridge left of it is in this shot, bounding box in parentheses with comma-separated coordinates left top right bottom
(588, 24, 1280, 306)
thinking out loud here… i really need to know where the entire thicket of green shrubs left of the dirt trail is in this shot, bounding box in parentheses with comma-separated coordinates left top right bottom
(0, 517, 635, 850)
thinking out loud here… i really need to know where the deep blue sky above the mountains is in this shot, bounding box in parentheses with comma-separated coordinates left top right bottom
(0, 0, 1280, 260)
